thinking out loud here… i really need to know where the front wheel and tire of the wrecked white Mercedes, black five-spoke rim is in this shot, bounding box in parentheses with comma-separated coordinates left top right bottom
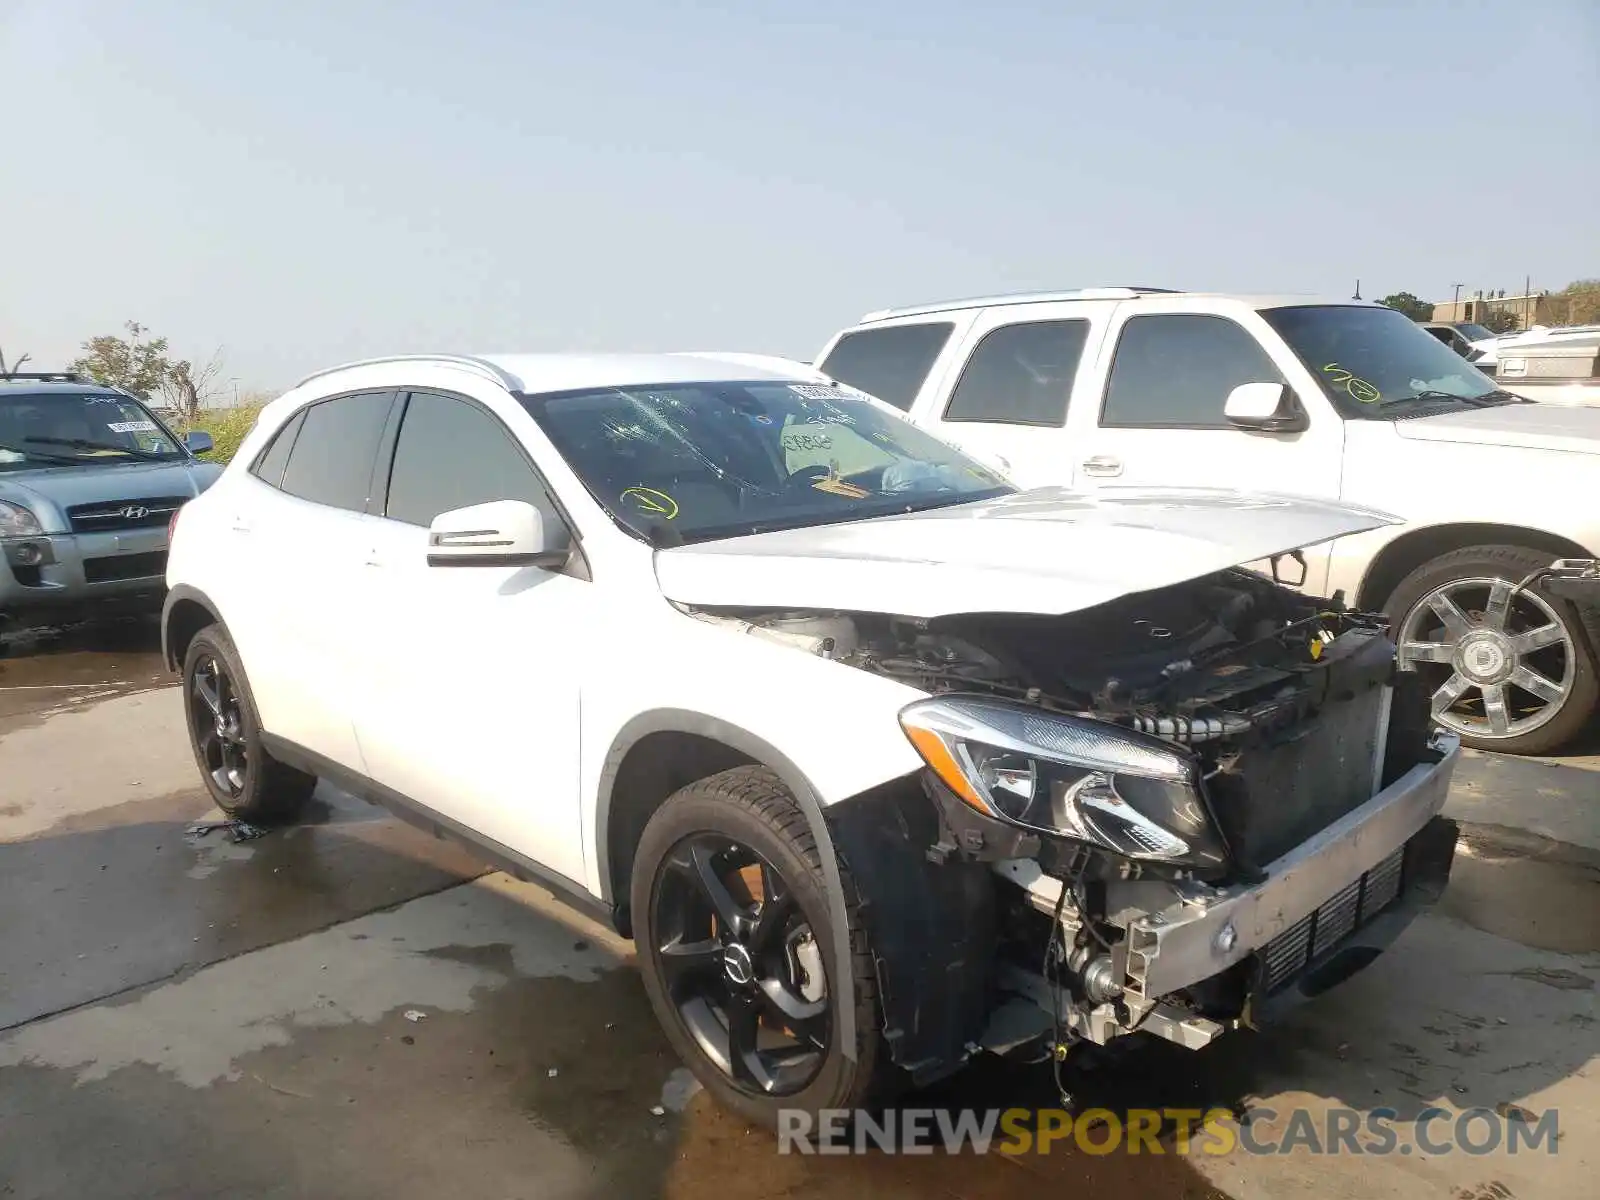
(632, 766, 894, 1128)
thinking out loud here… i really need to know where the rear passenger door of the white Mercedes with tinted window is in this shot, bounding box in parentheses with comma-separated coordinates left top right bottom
(228, 390, 394, 771)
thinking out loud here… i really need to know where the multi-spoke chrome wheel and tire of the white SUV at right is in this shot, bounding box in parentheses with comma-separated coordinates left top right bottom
(1384, 546, 1600, 754)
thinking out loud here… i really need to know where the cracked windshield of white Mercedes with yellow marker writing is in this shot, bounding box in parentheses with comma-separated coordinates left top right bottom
(523, 382, 1014, 542)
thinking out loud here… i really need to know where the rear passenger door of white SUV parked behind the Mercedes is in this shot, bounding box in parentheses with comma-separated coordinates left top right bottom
(917, 302, 1112, 488)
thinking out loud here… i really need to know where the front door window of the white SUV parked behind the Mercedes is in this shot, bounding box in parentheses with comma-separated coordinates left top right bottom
(1101, 312, 1286, 429)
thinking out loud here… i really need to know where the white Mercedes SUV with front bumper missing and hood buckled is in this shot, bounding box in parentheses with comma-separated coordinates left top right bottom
(163, 355, 1459, 1125)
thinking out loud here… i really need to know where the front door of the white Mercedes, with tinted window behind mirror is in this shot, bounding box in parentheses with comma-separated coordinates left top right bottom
(355, 392, 597, 880)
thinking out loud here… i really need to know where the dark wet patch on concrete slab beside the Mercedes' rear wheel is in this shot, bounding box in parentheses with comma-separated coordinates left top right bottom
(0, 789, 488, 1029)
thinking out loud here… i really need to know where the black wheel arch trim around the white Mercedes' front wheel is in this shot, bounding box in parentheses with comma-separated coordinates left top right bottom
(595, 709, 856, 1061)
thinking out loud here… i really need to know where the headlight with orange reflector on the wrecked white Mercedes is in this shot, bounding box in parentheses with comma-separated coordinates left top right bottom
(901, 698, 1227, 872)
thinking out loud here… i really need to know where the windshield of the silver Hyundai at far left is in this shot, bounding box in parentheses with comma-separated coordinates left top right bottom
(0, 390, 184, 470)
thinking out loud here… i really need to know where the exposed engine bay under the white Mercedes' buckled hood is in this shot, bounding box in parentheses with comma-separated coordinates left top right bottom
(681, 568, 1433, 803)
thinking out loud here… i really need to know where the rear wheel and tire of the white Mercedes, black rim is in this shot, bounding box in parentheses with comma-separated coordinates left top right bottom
(182, 626, 317, 824)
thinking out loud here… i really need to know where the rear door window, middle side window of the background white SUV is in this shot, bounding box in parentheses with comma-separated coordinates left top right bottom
(944, 320, 1090, 427)
